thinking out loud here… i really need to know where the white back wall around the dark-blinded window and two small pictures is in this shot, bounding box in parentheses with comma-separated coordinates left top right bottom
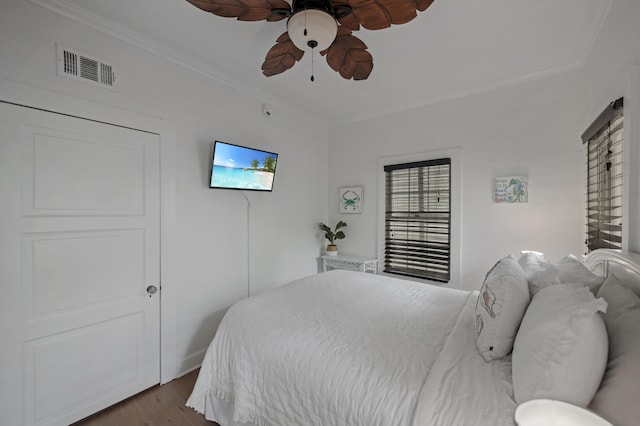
(329, 74, 584, 288)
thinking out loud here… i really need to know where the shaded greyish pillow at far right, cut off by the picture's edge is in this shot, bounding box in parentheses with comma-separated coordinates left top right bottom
(589, 275, 640, 426)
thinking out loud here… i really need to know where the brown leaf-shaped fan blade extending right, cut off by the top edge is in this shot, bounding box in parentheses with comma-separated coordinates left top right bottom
(334, 0, 434, 31)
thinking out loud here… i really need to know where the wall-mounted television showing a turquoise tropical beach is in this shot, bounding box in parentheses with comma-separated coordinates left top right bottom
(210, 141, 278, 191)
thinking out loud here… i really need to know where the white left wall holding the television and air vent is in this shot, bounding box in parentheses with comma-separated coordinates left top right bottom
(0, 1, 328, 372)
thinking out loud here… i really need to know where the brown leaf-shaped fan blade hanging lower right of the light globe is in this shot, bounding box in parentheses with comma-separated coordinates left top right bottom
(320, 27, 373, 80)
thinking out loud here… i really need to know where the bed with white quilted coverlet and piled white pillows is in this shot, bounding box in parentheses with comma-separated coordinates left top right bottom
(187, 250, 640, 426)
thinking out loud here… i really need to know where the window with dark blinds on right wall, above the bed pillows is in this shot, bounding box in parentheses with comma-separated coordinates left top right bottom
(582, 98, 623, 251)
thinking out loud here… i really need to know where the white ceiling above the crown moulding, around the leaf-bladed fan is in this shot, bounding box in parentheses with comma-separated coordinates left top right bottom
(37, 0, 613, 125)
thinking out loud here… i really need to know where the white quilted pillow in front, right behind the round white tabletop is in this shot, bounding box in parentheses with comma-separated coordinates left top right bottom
(512, 284, 609, 407)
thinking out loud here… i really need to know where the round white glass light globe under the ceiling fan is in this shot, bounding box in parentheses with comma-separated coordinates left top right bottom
(287, 9, 338, 52)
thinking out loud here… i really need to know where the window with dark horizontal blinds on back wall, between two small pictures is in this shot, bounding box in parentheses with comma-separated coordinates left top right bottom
(384, 158, 451, 282)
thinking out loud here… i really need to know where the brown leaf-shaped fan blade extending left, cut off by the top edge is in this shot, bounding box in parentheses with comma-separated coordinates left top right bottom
(187, 0, 291, 21)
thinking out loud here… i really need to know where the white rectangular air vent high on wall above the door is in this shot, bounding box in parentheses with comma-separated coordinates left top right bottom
(56, 44, 116, 90)
